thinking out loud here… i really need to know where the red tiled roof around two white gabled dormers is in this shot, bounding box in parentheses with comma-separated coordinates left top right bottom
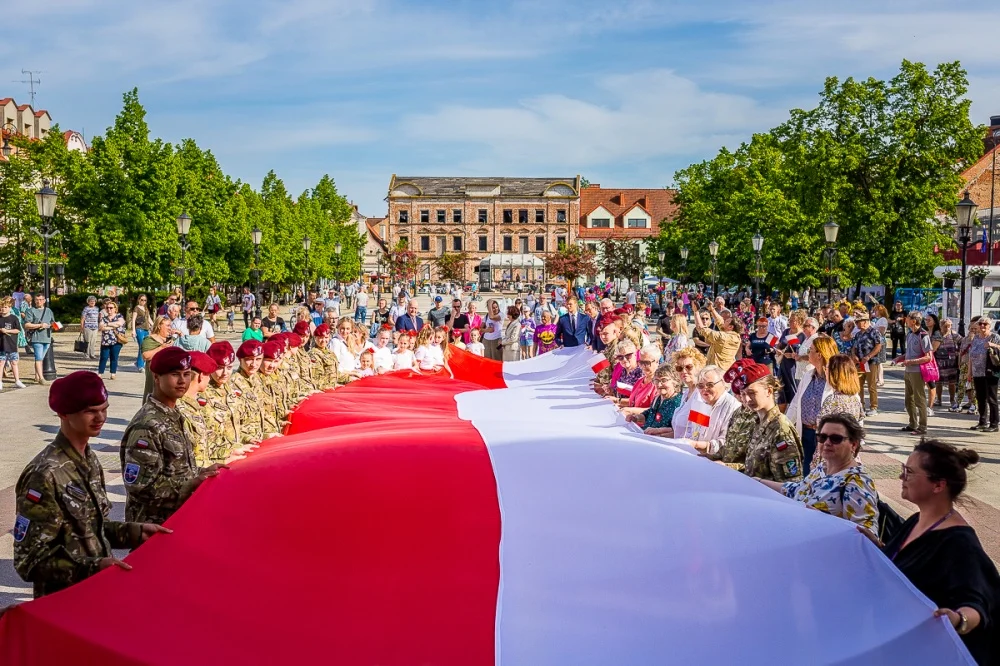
(578, 184, 680, 238)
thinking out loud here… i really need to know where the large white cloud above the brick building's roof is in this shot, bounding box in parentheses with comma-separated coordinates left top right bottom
(403, 70, 786, 169)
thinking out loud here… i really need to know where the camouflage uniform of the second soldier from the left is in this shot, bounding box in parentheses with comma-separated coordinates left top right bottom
(121, 396, 199, 524)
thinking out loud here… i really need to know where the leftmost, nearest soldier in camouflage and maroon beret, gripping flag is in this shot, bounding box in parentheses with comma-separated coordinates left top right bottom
(14, 370, 170, 598)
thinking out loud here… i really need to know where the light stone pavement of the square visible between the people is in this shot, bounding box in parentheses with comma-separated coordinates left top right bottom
(0, 296, 1000, 608)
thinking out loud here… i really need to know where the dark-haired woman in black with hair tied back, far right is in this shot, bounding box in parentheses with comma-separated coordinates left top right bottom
(882, 439, 1000, 664)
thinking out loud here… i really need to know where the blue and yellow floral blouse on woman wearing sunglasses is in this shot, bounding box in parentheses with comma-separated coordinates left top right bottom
(782, 461, 878, 532)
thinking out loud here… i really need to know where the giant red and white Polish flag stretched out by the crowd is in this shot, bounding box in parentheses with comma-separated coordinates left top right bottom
(0, 350, 972, 666)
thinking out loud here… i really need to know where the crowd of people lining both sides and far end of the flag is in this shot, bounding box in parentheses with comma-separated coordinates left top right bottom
(0, 288, 1000, 663)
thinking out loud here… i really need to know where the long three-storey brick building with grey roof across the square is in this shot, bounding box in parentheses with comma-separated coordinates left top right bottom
(382, 174, 580, 281)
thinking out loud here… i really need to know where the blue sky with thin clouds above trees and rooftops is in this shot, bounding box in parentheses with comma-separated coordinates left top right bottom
(0, 0, 1000, 215)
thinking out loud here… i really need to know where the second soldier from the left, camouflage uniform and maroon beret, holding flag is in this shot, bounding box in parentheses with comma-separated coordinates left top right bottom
(121, 347, 224, 523)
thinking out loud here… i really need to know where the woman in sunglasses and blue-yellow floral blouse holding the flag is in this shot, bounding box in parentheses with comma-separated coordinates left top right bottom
(758, 414, 878, 534)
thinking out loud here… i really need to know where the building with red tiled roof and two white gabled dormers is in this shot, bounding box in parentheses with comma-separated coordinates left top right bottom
(577, 183, 680, 279)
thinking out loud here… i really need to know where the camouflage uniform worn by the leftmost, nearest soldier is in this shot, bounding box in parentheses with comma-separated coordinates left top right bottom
(14, 432, 142, 598)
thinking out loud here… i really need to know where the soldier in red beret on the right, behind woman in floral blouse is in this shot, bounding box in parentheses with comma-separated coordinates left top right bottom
(733, 363, 803, 482)
